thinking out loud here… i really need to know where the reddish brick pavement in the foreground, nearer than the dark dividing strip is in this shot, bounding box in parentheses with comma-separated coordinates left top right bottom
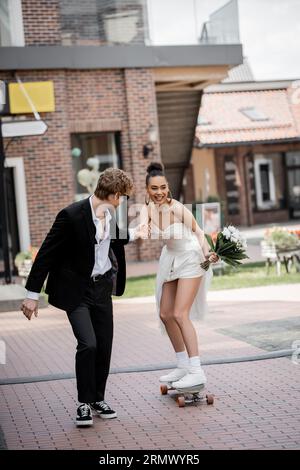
(0, 359, 300, 450)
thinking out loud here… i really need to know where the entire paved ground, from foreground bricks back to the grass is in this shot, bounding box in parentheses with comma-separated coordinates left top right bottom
(0, 285, 300, 450)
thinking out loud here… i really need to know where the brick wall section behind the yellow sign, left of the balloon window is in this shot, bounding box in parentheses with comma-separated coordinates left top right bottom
(5, 71, 74, 246)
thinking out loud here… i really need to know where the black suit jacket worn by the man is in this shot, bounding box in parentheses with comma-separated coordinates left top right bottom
(25, 198, 129, 311)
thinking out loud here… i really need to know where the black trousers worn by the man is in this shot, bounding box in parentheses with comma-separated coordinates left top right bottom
(67, 272, 113, 403)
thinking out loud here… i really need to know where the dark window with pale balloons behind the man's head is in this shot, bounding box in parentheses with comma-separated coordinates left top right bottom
(71, 132, 120, 200)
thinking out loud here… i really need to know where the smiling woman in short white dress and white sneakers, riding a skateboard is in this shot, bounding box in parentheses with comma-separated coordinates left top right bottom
(141, 163, 218, 388)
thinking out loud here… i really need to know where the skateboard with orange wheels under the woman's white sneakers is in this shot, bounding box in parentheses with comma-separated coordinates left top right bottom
(160, 383, 214, 408)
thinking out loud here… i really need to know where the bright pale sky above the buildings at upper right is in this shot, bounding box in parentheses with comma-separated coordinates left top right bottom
(148, 0, 300, 80)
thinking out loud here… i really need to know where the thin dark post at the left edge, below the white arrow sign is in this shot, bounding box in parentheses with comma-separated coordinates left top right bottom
(0, 118, 11, 284)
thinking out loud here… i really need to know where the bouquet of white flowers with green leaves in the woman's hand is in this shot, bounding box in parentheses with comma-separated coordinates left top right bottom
(201, 225, 249, 271)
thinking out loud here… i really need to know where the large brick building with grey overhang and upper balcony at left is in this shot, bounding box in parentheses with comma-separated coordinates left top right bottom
(0, 0, 242, 274)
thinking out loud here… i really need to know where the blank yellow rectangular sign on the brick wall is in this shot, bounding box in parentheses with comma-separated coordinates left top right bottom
(8, 82, 55, 114)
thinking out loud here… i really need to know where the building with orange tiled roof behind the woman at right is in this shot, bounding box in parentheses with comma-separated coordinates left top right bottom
(192, 76, 300, 226)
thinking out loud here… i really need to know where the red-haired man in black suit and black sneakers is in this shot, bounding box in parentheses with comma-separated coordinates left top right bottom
(21, 168, 133, 426)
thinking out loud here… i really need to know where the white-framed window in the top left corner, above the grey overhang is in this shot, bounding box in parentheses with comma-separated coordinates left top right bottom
(0, 0, 25, 47)
